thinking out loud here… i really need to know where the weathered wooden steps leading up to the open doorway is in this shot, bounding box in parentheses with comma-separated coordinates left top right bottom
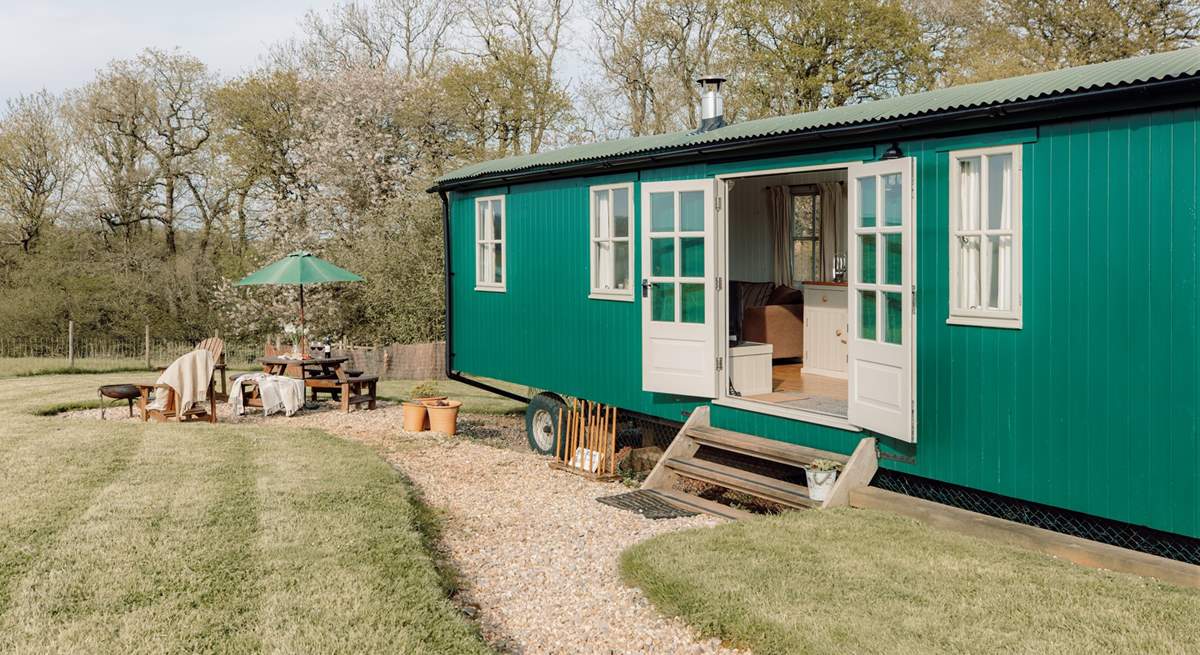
(642, 407, 876, 519)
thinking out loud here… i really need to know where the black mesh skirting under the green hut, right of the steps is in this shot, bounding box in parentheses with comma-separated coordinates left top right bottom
(871, 469, 1200, 564)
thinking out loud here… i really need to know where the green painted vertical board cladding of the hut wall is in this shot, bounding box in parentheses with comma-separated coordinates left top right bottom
(451, 108, 1200, 537)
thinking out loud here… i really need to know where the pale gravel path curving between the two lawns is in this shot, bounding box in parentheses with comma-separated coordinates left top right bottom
(64, 403, 739, 654)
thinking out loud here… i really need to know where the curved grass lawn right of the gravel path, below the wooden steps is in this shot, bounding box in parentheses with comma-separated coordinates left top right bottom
(620, 510, 1200, 655)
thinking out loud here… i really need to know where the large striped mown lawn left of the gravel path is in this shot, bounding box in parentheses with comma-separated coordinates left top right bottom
(0, 373, 487, 655)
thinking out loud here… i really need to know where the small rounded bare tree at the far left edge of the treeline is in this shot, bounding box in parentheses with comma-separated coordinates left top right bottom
(0, 91, 73, 254)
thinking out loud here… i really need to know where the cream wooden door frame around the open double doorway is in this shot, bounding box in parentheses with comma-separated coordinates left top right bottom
(714, 161, 863, 432)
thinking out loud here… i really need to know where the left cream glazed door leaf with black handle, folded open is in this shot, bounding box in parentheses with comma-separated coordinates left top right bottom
(642, 180, 718, 398)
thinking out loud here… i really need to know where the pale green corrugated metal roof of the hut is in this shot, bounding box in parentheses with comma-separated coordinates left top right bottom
(438, 47, 1200, 185)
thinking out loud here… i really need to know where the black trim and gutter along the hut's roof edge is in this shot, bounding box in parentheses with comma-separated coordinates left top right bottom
(426, 76, 1200, 193)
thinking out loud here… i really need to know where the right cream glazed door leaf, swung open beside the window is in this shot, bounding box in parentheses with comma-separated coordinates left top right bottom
(847, 157, 917, 441)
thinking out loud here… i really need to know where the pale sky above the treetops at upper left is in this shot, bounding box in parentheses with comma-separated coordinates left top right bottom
(0, 0, 336, 103)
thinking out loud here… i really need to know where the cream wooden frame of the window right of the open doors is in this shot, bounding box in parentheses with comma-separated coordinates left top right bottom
(946, 144, 1024, 330)
